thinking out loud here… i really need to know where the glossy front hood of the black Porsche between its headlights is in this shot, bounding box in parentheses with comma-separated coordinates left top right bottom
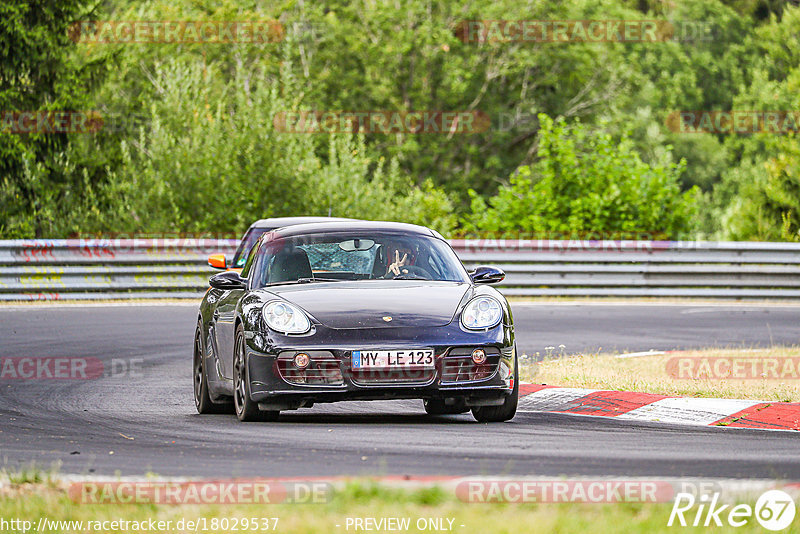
(268, 280, 472, 328)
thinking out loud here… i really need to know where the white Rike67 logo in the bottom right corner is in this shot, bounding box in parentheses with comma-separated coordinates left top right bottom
(667, 490, 796, 531)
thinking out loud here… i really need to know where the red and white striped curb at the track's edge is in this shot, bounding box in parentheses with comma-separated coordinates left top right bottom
(517, 384, 800, 431)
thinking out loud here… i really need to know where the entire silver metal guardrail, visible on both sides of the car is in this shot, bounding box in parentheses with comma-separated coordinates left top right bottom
(0, 239, 800, 301)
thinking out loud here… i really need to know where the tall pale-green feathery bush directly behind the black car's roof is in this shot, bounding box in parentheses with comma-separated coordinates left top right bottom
(94, 54, 455, 237)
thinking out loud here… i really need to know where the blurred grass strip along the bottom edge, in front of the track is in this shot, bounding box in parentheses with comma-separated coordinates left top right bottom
(0, 482, 776, 534)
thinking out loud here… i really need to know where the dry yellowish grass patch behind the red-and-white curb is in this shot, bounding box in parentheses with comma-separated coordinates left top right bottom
(520, 347, 800, 402)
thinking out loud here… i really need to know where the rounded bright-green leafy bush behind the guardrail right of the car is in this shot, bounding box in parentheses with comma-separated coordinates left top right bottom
(463, 115, 696, 238)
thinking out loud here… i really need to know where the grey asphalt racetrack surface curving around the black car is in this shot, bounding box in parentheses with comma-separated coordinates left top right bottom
(0, 303, 800, 480)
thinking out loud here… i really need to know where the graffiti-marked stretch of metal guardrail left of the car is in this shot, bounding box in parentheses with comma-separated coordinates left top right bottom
(0, 239, 239, 301)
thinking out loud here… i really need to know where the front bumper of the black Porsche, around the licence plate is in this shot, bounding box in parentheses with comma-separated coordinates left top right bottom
(246, 325, 516, 410)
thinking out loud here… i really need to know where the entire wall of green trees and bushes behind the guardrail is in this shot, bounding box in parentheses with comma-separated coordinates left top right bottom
(0, 0, 800, 240)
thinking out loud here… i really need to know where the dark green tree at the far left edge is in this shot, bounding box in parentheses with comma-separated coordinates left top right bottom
(0, 0, 103, 237)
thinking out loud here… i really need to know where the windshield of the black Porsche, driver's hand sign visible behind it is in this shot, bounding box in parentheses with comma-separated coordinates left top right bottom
(247, 232, 469, 287)
